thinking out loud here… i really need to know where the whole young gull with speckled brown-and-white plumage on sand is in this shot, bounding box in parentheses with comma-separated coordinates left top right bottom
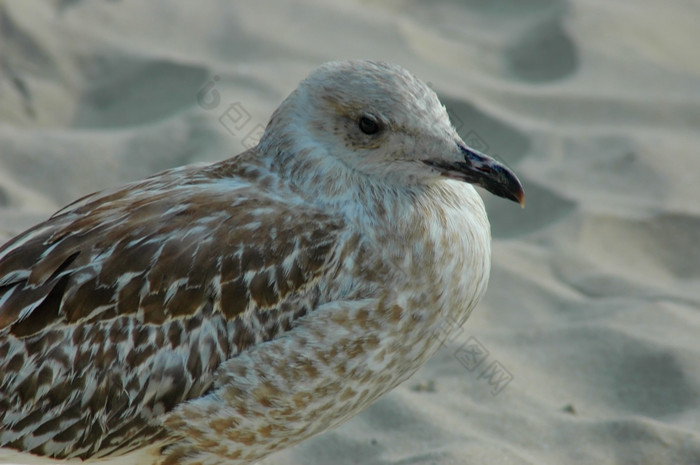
(0, 61, 523, 465)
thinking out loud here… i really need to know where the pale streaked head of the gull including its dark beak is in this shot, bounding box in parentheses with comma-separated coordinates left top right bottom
(263, 60, 524, 205)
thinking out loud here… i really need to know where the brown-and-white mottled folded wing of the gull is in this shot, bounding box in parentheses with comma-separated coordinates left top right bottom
(0, 158, 343, 459)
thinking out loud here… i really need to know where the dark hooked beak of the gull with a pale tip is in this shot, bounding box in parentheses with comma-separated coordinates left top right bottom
(423, 143, 525, 207)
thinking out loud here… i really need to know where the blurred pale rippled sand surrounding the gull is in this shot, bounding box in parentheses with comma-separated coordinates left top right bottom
(0, 0, 700, 465)
